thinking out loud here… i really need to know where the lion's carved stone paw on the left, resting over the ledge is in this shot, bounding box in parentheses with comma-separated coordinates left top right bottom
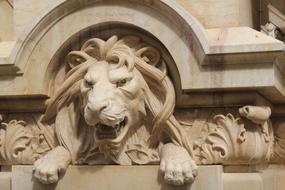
(34, 147, 71, 184)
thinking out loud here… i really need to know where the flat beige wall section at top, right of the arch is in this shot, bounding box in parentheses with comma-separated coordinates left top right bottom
(176, 0, 257, 28)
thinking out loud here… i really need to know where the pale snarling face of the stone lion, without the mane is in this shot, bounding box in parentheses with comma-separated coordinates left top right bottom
(80, 61, 146, 142)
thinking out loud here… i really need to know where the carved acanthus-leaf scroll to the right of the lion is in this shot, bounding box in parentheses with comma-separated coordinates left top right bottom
(195, 106, 273, 164)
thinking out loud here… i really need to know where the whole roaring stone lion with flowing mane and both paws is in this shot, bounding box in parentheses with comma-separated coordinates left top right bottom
(34, 36, 197, 185)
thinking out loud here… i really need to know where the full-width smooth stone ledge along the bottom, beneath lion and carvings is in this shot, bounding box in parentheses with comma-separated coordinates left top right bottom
(8, 165, 285, 190)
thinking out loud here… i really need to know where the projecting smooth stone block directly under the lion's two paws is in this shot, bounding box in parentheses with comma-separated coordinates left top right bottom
(12, 166, 222, 190)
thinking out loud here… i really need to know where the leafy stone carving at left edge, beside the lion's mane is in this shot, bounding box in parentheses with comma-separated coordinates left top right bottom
(0, 116, 55, 165)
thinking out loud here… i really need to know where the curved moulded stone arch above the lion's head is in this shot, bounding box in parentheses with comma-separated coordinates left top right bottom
(4, 0, 207, 101)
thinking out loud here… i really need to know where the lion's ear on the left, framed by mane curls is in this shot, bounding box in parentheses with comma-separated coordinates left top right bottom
(67, 51, 91, 69)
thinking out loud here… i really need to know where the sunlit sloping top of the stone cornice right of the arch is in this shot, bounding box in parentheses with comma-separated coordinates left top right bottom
(206, 27, 285, 54)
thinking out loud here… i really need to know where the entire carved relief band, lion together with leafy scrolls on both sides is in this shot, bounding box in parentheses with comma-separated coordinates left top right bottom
(0, 36, 285, 185)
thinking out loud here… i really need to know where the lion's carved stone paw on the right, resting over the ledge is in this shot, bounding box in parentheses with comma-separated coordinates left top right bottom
(160, 144, 198, 186)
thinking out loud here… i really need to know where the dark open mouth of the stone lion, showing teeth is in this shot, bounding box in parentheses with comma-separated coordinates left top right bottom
(96, 118, 127, 139)
